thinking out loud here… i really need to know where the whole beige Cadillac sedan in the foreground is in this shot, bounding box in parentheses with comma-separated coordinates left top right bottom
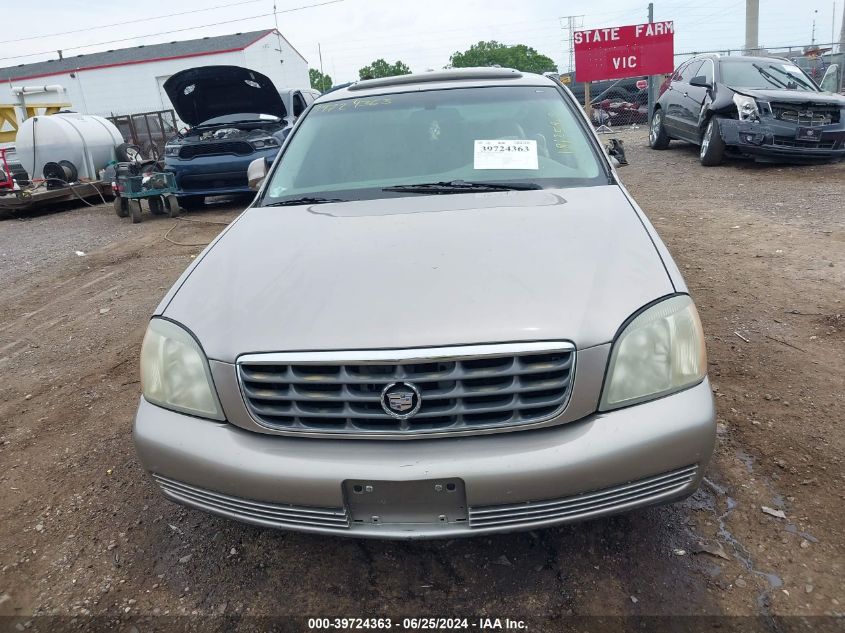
(134, 68, 715, 538)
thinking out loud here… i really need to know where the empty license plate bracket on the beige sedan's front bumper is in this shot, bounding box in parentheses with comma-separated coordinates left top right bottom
(343, 477, 467, 527)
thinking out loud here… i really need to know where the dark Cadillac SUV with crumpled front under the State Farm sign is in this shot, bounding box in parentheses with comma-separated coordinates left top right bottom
(649, 55, 845, 166)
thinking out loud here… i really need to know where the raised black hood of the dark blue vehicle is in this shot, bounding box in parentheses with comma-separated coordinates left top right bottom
(164, 66, 287, 125)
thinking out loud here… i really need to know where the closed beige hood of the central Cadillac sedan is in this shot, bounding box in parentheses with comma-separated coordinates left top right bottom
(164, 186, 674, 362)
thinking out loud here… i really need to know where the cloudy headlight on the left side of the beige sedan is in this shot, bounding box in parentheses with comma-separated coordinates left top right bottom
(141, 319, 225, 420)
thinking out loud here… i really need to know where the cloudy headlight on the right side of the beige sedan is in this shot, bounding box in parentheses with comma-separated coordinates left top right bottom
(600, 295, 707, 411)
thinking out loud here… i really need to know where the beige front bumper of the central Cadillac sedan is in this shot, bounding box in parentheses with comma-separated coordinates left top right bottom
(133, 379, 715, 538)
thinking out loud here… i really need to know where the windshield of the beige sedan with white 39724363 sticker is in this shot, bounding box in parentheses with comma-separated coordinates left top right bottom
(262, 86, 607, 204)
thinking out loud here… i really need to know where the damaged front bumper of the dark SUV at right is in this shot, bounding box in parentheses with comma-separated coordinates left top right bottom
(719, 117, 845, 160)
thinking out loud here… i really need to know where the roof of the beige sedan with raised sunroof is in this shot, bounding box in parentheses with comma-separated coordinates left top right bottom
(320, 68, 559, 103)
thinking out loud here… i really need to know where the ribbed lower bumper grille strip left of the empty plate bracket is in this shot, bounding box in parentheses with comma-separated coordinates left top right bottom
(153, 474, 349, 529)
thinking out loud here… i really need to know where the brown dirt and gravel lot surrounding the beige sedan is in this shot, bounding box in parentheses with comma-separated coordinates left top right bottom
(0, 129, 845, 631)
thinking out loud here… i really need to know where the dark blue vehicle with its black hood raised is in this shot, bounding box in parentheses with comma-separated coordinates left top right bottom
(164, 66, 290, 209)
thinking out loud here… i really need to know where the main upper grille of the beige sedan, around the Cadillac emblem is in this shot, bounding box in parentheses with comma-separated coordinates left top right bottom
(238, 342, 575, 435)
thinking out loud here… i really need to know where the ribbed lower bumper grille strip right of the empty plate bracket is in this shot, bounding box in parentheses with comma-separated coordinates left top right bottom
(469, 466, 698, 529)
